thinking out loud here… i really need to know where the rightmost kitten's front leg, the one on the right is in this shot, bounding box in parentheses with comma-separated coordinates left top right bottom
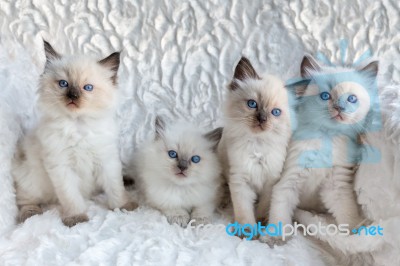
(321, 167, 363, 230)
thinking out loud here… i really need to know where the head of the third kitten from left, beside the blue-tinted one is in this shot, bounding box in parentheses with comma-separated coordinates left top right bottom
(226, 57, 290, 134)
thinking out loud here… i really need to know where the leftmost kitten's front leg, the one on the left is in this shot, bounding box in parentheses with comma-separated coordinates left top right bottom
(45, 162, 89, 227)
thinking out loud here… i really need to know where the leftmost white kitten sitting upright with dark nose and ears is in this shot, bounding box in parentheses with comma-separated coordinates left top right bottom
(13, 39, 136, 226)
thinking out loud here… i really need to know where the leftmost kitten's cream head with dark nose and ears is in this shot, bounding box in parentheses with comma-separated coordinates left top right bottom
(38, 41, 119, 116)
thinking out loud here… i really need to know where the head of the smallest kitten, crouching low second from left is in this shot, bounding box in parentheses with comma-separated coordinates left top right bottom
(148, 117, 222, 184)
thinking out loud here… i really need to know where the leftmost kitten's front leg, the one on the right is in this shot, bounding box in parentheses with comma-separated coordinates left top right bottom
(99, 159, 138, 211)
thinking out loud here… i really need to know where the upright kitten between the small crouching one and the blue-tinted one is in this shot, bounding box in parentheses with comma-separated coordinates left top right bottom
(218, 57, 294, 230)
